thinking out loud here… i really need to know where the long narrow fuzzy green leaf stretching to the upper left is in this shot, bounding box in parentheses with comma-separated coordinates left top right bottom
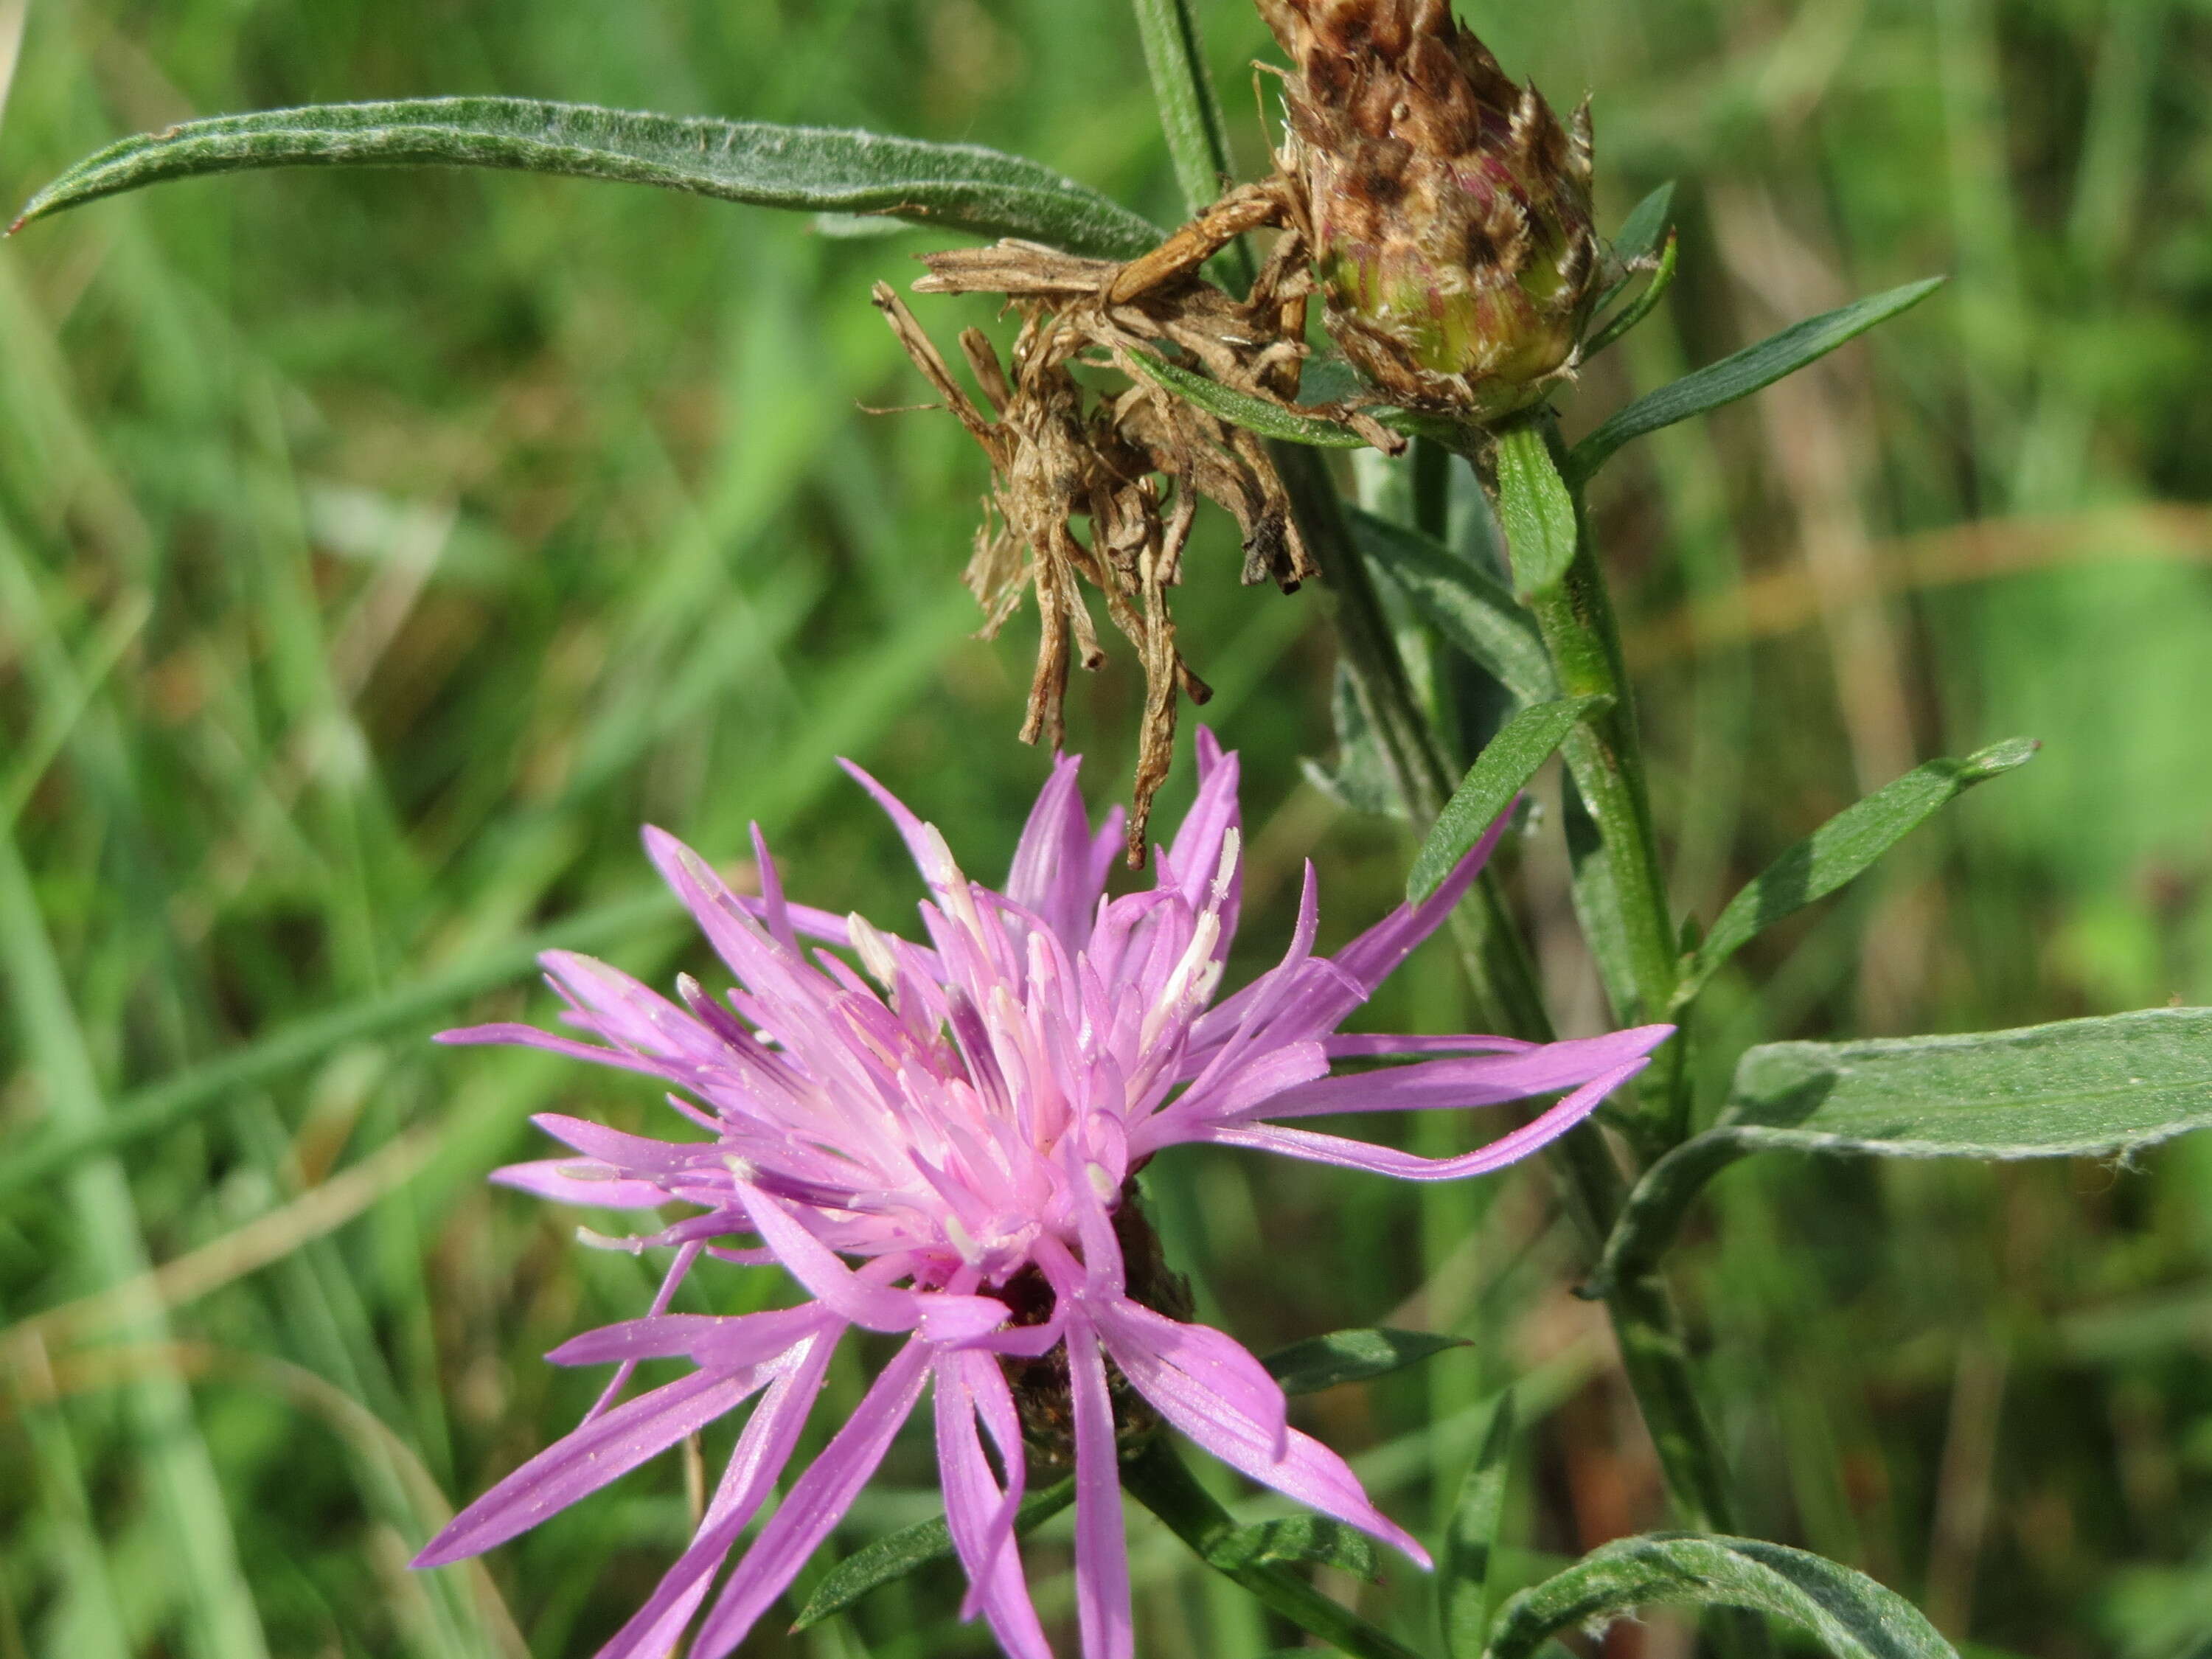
(15, 97, 1161, 259)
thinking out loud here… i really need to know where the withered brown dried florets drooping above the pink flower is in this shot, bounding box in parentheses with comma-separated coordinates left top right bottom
(876, 195, 1354, 865)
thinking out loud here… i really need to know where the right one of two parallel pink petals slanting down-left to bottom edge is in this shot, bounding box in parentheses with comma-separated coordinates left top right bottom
(692, 1338, 929, 1659)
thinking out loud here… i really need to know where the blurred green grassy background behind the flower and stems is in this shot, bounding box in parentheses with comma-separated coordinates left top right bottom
(0, 0, 2212, 1659)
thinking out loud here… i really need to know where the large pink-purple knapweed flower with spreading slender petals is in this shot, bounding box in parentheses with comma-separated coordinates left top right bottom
(416, 732, 1670, 1659)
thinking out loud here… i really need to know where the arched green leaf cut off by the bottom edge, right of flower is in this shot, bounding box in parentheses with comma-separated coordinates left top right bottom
(1486, 1533, 1958, 1659)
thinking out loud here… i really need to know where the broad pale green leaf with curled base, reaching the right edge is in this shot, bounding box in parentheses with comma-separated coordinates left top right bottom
(1595, 1009, 2212, 1290)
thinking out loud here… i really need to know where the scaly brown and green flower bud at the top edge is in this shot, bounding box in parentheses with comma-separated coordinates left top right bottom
(1259, 0, 1601, 420)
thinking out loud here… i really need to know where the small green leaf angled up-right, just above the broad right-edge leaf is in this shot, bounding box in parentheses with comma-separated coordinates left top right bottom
(1674, 737, 2039, 1006)
